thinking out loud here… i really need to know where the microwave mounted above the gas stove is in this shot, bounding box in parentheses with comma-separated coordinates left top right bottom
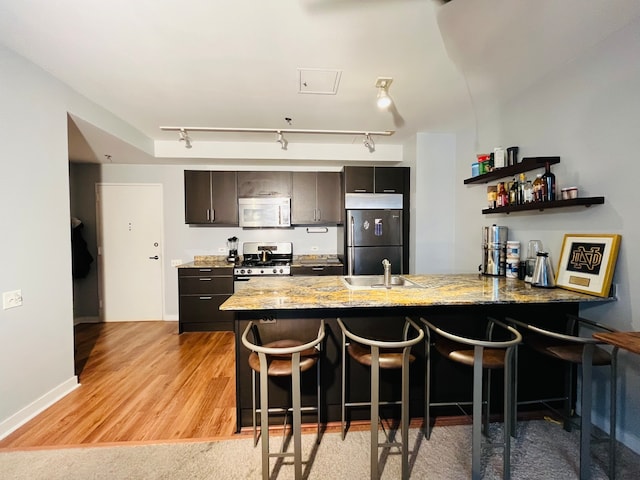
(238, 197, 291, 227)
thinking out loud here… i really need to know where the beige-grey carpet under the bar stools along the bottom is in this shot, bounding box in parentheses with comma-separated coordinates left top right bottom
(0, 420, 640, 480)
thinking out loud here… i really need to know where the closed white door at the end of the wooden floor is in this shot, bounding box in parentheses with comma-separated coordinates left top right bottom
(96, 184, 164, 322)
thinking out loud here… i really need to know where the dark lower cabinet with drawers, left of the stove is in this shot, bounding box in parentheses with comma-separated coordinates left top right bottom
(178, 267, 235, 333)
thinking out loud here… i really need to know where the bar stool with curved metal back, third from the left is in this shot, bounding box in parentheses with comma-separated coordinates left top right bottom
(420, 318, 522, 480)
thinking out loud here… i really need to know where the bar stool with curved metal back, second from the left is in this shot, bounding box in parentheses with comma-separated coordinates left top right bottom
(337, 318, 424, 480)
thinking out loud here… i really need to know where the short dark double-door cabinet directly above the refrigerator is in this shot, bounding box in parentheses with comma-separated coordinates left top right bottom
(344, 167, 409, 193)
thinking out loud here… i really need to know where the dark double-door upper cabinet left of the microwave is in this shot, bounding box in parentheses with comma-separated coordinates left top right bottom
(184, 170, 238, 226)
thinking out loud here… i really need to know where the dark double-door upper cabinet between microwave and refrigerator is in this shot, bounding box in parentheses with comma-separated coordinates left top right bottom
(291, 172, 344, 225)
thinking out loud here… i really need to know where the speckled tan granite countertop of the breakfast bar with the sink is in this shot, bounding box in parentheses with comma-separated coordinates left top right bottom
(220, 274, 608, 311)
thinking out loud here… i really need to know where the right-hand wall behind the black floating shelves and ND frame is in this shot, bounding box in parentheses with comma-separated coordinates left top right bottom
(455, 15, 640, 452)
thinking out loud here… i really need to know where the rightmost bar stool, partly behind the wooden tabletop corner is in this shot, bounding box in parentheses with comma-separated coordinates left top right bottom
(505, 315, 618, 479)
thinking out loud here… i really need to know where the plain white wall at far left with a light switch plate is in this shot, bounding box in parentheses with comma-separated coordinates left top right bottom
(0, 47, 77, 436)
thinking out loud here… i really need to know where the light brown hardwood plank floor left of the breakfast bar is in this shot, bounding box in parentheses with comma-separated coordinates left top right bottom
(0, 322, 236, 448)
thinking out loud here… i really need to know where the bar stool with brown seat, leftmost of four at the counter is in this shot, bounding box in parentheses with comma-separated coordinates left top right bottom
(242, 320, 325, 480)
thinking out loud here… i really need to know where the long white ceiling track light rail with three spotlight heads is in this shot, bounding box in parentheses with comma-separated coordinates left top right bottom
(160, 127, 395, 152)
